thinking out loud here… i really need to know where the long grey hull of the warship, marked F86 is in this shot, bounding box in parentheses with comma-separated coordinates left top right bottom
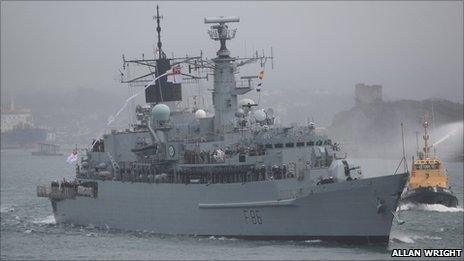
(52, 174, 407, 243)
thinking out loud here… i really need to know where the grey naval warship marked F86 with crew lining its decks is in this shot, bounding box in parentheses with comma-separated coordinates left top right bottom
(37, 7, 408, 244)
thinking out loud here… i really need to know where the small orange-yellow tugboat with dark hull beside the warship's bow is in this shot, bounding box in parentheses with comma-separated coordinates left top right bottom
(402, 115, 458, 207)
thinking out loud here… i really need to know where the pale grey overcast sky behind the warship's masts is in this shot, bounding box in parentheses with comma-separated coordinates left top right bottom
(1, 1, 463, 103)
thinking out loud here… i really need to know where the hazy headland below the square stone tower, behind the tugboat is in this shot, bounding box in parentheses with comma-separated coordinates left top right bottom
(328, 99, 464, 161)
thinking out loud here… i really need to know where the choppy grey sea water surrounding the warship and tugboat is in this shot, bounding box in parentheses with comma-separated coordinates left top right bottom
(0, 150, 463, 260)
